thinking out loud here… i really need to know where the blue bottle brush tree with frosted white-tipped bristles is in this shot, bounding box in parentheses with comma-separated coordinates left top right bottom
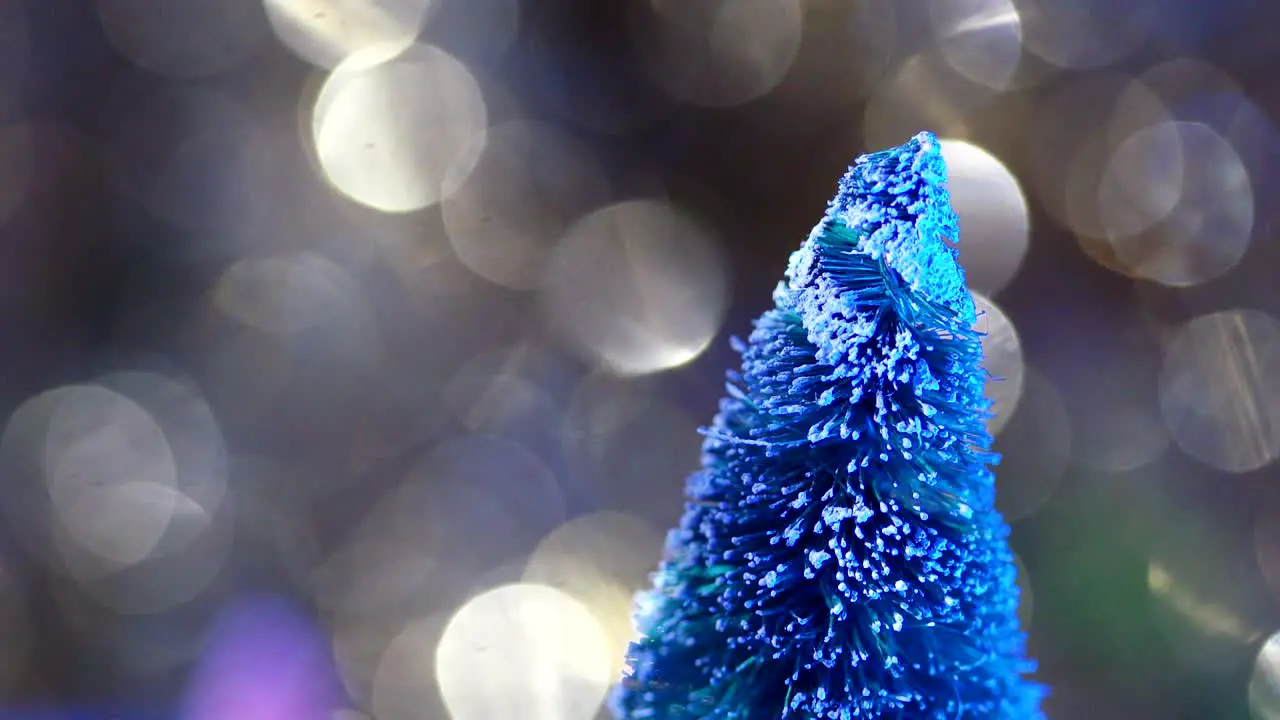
(611, 133, 1044, 720)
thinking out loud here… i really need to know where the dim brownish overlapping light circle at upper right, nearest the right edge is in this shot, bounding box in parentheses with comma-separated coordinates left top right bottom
(1098, 122, 1253, 287)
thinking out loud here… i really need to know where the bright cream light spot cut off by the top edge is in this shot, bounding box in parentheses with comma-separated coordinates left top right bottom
(264, 0, 434, 68)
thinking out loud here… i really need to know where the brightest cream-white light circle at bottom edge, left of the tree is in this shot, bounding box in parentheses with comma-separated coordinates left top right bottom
(435, 584, 614, 720)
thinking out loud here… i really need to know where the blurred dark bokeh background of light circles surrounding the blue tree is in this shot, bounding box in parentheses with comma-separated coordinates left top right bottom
(0, 0, 1280, 720)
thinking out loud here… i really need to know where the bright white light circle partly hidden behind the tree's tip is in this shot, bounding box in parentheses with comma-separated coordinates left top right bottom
(942, 140, 1029, 295)
